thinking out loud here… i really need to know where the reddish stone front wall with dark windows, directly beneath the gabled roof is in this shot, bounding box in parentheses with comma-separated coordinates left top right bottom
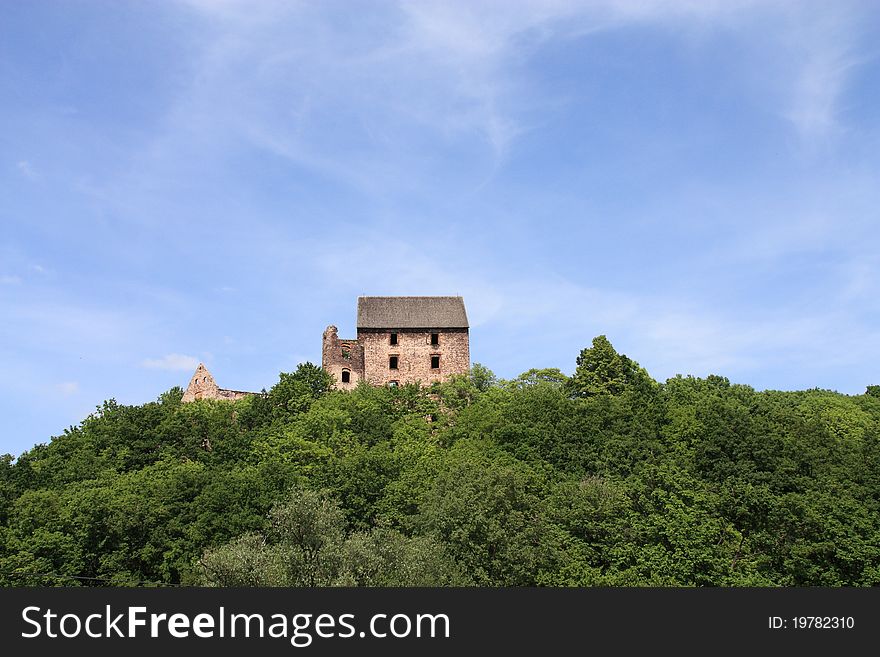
(358, 329, 471, 385)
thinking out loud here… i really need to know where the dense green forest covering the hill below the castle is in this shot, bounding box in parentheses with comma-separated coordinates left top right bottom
(0, 336, 880, 587)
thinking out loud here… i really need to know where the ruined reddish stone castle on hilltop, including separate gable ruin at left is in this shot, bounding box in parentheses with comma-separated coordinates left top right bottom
(182, 297, 470, 402)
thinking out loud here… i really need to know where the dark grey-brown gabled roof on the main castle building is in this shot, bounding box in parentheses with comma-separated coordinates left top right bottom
(357, 297, 468, 329)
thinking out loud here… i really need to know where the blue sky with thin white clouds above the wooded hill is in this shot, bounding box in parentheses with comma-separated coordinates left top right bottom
(0, 0, 880, 455)
